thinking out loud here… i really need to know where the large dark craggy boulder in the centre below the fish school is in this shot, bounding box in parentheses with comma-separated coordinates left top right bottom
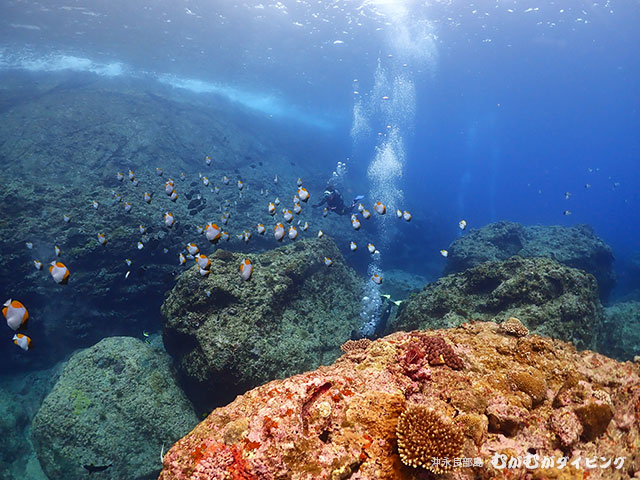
(162, 237, 361, 403)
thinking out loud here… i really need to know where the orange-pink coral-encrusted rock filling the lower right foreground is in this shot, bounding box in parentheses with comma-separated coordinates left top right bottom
(160, 319, 640, 480)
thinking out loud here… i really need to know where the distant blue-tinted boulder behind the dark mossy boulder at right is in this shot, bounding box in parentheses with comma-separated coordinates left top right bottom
(444, 222, 616, 300)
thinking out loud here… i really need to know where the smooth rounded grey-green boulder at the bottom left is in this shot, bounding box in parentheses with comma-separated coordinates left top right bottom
(31, 337, 197, 480)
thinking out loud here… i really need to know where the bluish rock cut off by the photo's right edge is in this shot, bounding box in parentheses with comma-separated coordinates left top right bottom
(599, 301, 640, 360)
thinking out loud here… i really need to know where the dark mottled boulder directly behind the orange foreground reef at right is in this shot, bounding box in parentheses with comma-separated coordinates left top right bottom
(390, 257, 603, 348)
